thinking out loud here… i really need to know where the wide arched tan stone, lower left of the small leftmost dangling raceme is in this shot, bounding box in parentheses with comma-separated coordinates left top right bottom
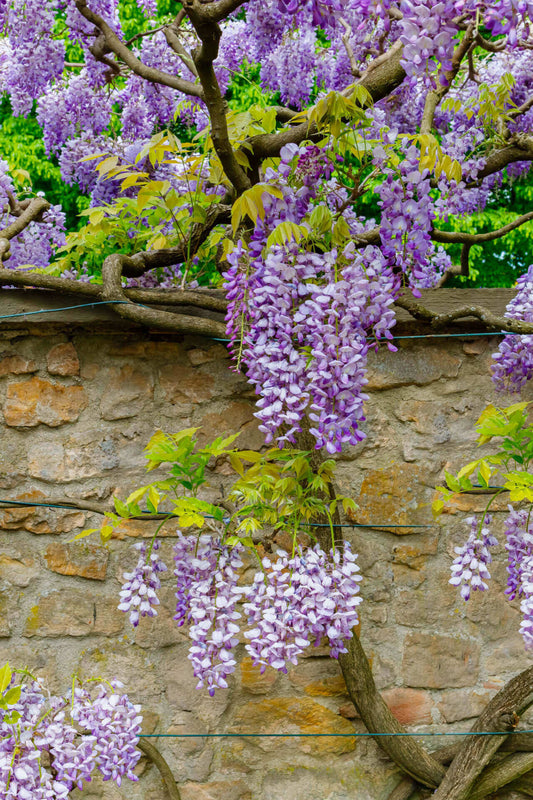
(24, 589, 125, 637)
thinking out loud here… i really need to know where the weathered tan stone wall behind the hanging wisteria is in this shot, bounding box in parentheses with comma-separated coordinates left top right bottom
(0, 293, 531, 800)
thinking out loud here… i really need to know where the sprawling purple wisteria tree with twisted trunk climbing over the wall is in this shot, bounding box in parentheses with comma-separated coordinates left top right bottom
(4, 0, 533, 800)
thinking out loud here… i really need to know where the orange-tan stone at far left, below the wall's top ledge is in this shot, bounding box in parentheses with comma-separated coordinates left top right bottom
(4, 377, 88, 428)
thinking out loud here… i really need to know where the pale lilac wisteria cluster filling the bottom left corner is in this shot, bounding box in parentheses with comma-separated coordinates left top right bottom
(0, 677, 142, 800)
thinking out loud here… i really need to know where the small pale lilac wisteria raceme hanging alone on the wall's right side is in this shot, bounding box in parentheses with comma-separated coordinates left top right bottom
(449, 516, 498, 600)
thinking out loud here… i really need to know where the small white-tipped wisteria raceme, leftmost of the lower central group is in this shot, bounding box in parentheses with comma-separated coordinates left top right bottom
(118, 539, 167, 627)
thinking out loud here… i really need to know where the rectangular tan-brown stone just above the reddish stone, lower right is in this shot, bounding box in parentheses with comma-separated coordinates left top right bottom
(403, 633, 479, 689)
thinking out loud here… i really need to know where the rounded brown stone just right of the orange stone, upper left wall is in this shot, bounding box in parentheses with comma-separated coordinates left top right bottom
(100, 364, 154, 420)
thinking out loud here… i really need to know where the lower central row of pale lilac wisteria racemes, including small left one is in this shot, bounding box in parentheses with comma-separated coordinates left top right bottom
(119, 534, 361, 695)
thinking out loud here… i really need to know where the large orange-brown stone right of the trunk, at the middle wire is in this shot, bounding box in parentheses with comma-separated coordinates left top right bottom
(349, 462, 433, 536)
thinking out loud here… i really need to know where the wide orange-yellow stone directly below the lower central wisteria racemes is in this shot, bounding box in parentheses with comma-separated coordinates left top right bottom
(230, 697, 355, 755)
